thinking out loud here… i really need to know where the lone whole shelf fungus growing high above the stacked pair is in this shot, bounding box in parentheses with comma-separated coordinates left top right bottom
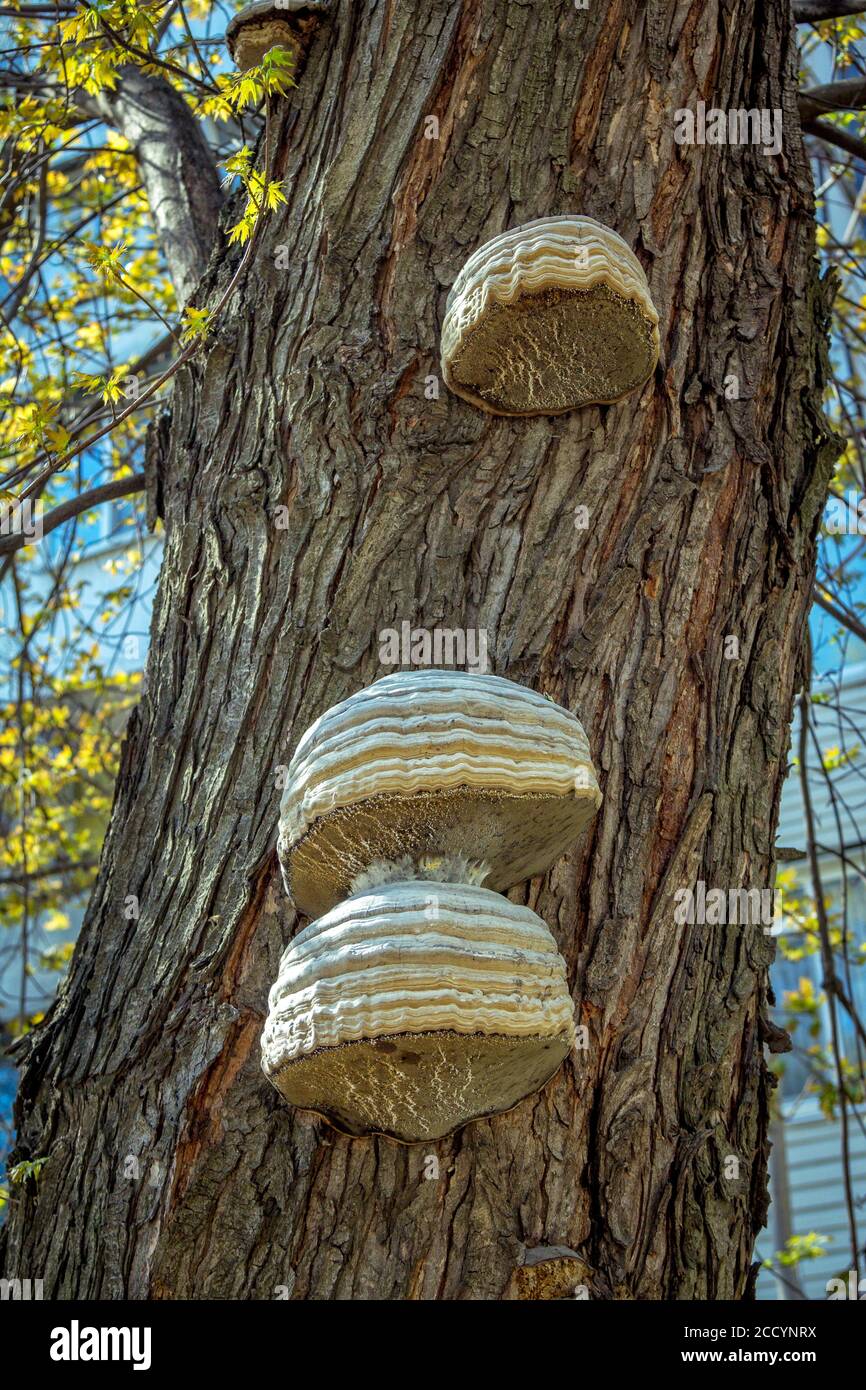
(442, 217, 659, 416)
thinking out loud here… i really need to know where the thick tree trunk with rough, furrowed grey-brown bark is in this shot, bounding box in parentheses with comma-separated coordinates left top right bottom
(6, 0, 835, 1298)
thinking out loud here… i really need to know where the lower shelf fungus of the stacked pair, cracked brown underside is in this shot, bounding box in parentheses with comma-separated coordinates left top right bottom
(261, 880, 574, 1144)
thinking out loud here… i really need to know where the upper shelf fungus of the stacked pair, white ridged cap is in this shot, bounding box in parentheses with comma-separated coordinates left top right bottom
(277, 670, 602, 917)
